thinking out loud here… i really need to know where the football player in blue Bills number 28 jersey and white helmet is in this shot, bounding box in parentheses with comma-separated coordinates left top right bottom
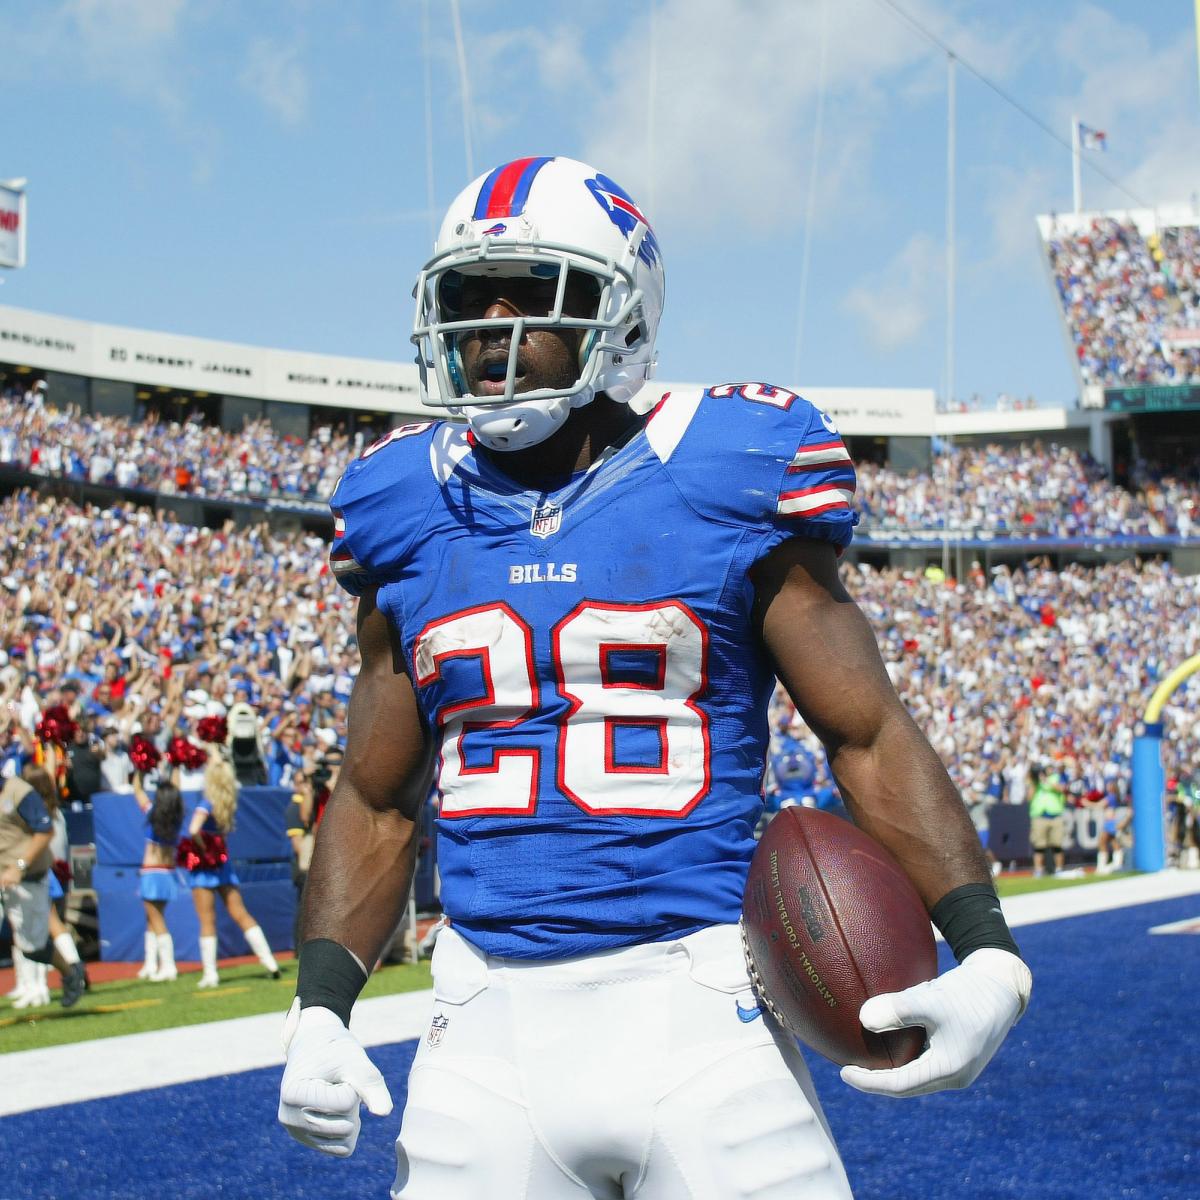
(280, 157, 1030, 1200)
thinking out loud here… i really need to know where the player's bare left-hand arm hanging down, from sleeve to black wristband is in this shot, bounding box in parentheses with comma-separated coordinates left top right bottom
(297, 580, 432, 968)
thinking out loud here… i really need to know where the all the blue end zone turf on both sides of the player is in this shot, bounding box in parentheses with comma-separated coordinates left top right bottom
(0, 896, 1200, 1200)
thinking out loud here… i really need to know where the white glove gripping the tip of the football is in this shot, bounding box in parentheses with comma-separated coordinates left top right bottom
(841, 948, 1033, 1096)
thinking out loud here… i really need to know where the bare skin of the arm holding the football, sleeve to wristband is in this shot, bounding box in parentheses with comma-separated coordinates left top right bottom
(754, 539, 991, 908)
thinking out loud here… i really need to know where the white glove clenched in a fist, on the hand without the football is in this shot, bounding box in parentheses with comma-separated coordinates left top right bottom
(280, 998, 391, 1158)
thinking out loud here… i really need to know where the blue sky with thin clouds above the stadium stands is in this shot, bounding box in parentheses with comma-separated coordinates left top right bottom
(0, 0, 1200, 403)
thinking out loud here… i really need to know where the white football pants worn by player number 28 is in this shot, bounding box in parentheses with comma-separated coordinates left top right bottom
(391, 925, 851, 1200)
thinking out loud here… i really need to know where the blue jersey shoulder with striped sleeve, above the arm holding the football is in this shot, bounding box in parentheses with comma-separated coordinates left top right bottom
(647, 383, 858, 547)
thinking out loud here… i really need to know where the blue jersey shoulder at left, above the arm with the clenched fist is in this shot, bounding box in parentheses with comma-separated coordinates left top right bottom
(329, 421, 446, 595)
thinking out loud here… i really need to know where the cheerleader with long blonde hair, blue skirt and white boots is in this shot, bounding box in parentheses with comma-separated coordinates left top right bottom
(179, 746, 280, 988)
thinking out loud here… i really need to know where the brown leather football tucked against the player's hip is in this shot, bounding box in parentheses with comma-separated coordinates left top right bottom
(742, 805, 937, 1069)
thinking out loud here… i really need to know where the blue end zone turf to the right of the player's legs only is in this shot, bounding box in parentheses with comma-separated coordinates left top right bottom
(809, 896, 1200, 1200)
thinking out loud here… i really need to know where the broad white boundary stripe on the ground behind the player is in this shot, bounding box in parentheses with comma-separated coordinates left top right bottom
(0, 870, 1200, 1117)
